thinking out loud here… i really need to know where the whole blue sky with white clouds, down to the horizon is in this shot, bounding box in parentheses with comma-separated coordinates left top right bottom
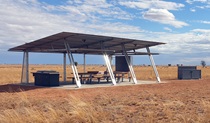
(0, 0, 210, 65)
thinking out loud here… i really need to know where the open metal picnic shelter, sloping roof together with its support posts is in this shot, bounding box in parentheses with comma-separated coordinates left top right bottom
(9, 32, 165, 87)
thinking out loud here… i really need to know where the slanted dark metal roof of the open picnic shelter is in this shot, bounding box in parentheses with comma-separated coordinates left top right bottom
(9, 32, 165, 54)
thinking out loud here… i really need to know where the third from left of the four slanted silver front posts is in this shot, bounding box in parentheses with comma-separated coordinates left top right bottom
(121, 44, 137, 84)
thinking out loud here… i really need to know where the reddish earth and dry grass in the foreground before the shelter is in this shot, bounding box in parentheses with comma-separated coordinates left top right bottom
(0, 82, 210, 123)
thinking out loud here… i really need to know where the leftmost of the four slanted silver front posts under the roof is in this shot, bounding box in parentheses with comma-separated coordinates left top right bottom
(64, 41, 81, 88)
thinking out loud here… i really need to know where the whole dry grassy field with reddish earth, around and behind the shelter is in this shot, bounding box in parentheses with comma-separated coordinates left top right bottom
(0, 65, 210, 123)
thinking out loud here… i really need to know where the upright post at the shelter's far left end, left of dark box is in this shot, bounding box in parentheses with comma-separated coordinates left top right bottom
(21, 51, 29, 83)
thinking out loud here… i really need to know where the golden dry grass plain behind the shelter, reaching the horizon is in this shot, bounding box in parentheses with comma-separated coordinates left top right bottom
(0, 65, 210, 84)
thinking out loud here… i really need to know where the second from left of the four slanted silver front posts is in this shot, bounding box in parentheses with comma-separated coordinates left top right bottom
(101, 42, 116, 85)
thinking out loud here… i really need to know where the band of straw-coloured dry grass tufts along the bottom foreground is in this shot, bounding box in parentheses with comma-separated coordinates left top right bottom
(0, 89, 210, 123)
